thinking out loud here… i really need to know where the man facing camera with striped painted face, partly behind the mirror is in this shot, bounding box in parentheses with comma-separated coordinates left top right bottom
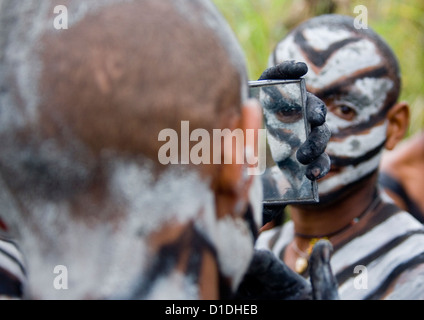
(257, 15, 424, 299)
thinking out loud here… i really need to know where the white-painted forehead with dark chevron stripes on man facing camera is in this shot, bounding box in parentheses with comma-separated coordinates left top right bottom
(272, 26, 383, 92)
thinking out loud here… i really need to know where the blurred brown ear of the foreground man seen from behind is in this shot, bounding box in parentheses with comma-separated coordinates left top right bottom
(216, 99, 262, 216)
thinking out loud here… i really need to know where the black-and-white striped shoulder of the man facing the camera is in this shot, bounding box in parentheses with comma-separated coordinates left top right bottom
(331, 211, 424, 299)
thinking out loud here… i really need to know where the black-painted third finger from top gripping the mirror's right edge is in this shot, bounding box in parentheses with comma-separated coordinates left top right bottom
(296, 123, 331, 164)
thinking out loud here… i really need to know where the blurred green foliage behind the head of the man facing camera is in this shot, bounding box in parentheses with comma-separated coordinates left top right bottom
(213, 0, 424, 136)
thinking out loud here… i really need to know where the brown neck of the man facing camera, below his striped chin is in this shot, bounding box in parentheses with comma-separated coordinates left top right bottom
(290, 172, 377, 245)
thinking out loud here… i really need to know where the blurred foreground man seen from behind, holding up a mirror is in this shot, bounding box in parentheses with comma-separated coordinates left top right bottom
(0, 0, 335, 299)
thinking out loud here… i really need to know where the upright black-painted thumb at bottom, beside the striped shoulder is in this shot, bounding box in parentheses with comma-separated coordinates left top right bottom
(309, 239, 340, 300)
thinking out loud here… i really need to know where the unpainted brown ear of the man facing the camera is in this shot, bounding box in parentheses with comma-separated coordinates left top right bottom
(385, 102, 409, 150)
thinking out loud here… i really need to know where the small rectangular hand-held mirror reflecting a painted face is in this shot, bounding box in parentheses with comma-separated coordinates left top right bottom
(249, 79, 318, 205)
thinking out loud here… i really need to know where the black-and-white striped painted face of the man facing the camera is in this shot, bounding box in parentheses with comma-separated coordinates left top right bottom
(270, 23, 395, 202)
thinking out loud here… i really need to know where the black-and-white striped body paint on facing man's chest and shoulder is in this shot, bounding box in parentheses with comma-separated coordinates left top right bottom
(256, 203, 424, 300)
